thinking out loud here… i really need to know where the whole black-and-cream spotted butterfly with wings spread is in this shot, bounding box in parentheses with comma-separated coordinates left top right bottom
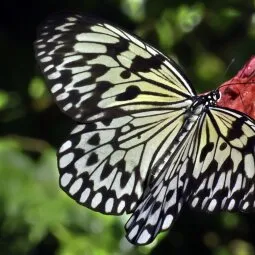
(35, 14, 255, 244)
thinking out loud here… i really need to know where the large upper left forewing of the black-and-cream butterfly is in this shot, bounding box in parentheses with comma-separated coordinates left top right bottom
(35, 14, 195, 123)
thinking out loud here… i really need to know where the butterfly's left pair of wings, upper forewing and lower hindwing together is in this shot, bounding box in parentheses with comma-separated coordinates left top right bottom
(35, 14, 195, 214)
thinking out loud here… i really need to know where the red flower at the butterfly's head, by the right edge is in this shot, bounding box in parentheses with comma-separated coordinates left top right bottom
(217, 56, 255, 119)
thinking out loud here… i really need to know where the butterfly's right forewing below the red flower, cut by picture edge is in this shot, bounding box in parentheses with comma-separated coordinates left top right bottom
(188, 107, 255, 212)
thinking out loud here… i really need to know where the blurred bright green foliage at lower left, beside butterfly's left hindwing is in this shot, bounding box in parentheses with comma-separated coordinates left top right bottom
(0, 138, 148, 255)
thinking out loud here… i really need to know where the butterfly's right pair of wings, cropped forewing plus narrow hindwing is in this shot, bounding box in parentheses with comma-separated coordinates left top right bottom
(126, 107, 255, 244)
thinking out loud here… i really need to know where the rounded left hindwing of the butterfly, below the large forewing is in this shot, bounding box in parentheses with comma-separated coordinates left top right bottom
(58, 106, 189, 214)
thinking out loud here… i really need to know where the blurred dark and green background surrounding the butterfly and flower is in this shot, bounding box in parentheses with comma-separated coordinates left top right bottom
(0, 0, 255, 255)
